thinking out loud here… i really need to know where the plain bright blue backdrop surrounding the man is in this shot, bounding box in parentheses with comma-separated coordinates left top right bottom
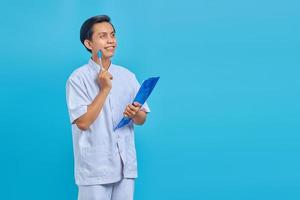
(0, 0, 300, 200)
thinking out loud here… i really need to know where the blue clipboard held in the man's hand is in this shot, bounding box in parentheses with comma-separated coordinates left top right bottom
(114, 77, 159, 131)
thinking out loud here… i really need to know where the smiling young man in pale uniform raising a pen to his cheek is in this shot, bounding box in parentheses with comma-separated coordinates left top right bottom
(66, 15, 150, 200)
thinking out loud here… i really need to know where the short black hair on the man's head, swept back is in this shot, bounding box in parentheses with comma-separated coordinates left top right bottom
(80, 15, 115, 52)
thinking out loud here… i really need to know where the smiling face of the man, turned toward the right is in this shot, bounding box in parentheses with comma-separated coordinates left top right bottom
(85, 22, 117, 58)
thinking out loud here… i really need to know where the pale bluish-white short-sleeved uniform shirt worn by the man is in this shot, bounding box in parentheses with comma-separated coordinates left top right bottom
(66, 59, 150, 198)
